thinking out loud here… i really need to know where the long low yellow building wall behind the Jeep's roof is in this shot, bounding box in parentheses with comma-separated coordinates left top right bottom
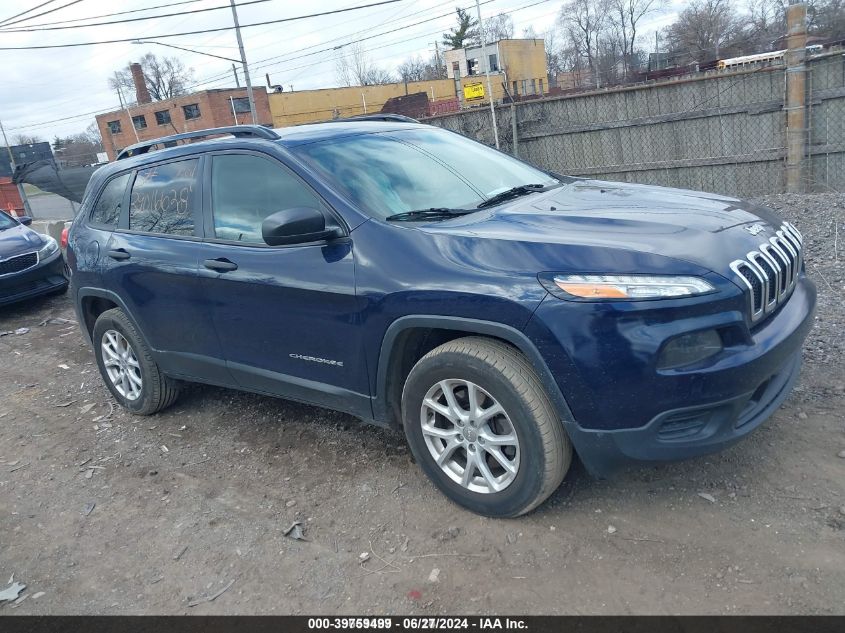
(269, 79, 455, 127)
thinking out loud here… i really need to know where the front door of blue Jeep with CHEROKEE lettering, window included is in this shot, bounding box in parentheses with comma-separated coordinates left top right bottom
(199, 151, 371, 415)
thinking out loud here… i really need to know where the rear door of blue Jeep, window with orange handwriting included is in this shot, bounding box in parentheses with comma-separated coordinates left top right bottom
(101, 156, 231, 384)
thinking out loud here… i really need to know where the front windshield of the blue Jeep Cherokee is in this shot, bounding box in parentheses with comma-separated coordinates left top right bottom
(291, 128, 558, 219)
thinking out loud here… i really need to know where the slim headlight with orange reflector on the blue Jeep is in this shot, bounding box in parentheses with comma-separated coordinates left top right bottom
(541, 275, 715, 299)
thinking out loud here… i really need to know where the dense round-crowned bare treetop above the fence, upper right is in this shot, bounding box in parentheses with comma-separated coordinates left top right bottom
(665, 0, 741, 61)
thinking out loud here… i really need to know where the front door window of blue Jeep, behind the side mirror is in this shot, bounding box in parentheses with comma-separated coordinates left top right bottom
(211, 154, 324, 244)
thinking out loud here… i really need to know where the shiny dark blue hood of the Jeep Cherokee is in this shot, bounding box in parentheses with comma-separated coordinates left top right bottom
(424, 180, 781, 275)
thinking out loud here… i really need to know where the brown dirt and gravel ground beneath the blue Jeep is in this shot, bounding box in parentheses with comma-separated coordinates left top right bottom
(0, 195, 845, 614)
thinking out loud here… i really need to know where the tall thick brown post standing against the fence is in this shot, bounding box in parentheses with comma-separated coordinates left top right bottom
(786, 3, 807, 192)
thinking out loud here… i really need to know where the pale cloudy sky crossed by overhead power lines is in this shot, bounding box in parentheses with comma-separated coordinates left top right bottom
(0, 0, 683, 143)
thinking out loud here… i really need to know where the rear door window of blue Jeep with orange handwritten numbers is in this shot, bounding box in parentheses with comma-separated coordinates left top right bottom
(129, 158, 199, 235)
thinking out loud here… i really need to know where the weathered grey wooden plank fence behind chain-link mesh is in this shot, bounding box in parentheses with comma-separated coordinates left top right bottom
(427, 53, 845, 197)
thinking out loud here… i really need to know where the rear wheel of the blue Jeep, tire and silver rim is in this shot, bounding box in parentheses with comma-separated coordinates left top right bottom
(92, 308, 179, 415)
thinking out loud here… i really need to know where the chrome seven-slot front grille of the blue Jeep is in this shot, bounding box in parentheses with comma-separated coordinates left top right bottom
(731, 222, 803, 321)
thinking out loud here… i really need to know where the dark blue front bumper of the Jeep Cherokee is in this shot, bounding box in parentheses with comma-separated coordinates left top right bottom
(526, 275, 816, 477)
